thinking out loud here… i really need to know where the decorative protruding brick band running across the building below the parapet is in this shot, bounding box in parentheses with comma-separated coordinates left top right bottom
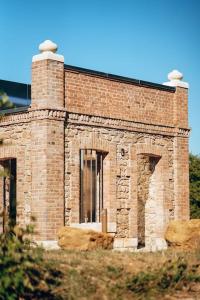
(0, 109, 190, 137)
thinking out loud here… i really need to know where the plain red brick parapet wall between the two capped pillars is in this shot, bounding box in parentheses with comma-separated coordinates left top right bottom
(65, 70, 183, 126)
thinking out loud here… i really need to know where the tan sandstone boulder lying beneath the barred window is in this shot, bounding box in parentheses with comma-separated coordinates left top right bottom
(58, 227, 113, 251)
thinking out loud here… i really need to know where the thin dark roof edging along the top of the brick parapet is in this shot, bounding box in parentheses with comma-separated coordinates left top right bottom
(64, 65, 176, 92)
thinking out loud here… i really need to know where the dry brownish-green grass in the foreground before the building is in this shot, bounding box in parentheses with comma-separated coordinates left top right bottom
(45, 250, 200, 300)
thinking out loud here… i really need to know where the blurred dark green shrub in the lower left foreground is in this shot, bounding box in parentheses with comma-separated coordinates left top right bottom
(0, 226, 61, 300)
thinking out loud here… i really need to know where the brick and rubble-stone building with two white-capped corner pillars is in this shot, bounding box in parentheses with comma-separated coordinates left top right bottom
(0, 41, 189, 250)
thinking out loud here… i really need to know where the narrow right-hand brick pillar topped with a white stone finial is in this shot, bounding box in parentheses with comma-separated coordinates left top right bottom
(165, 70, 190, 220)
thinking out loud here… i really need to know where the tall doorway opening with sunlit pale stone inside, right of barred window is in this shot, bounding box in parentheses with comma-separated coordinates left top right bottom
(137, 153, 164, 248)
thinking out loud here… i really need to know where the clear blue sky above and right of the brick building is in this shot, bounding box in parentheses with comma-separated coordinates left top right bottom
(0, 0, 200, 154)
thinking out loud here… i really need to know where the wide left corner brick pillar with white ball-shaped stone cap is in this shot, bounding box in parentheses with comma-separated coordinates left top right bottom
(31, 41, 65, 246)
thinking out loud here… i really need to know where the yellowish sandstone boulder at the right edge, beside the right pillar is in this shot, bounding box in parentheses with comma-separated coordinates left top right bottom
(165, 219, 200, 250)
